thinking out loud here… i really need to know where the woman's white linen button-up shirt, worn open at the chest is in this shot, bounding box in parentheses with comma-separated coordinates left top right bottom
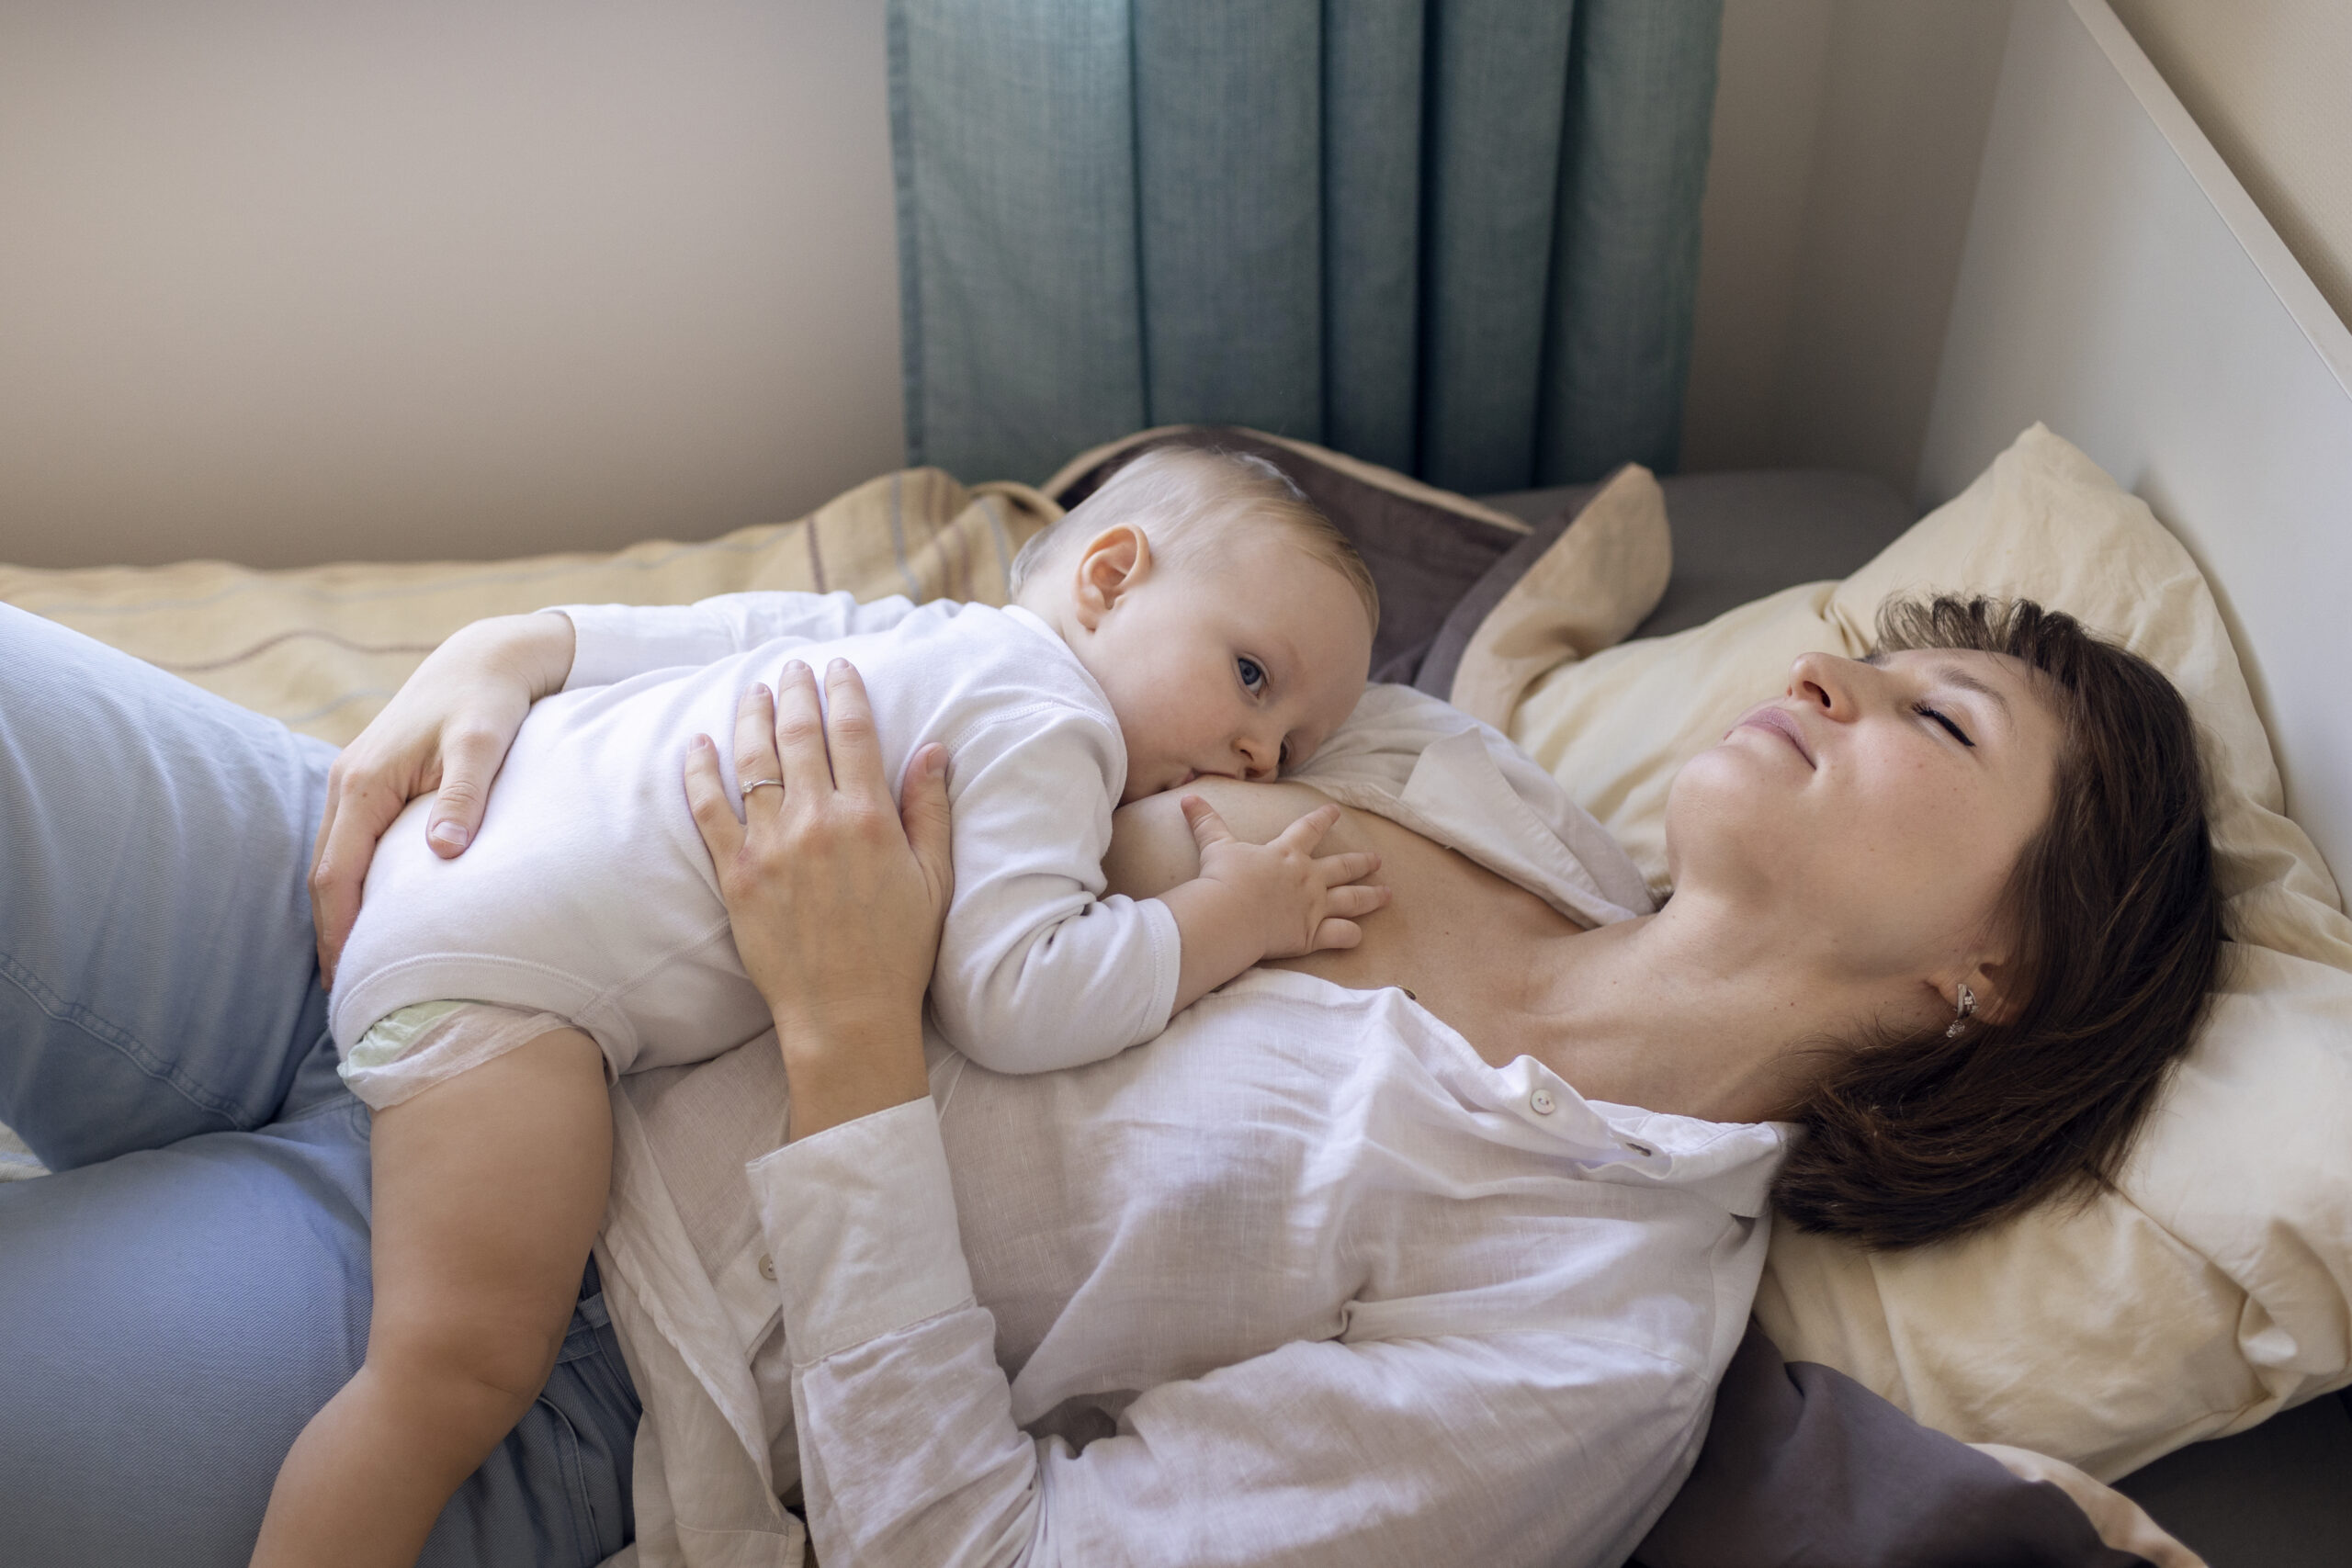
(574, 606, 1785, 1568)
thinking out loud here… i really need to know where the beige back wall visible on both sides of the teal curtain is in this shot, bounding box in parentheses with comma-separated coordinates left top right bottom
(0, 0, 2008, 564)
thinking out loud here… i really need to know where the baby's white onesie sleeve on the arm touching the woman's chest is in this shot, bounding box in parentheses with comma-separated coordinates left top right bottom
(932, 703, 1183, 1072)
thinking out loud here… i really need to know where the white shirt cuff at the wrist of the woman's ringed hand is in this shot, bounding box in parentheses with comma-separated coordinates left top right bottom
(746, 1098, 971, 1366)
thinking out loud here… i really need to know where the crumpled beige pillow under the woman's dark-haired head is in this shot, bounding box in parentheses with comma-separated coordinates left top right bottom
(1510, 425, 2352, 1476)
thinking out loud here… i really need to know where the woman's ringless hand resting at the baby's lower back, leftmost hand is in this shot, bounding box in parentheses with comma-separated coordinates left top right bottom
(311, 611, 571, 985)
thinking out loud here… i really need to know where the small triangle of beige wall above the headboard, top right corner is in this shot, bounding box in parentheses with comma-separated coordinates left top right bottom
(2114, 0, 2352, 322)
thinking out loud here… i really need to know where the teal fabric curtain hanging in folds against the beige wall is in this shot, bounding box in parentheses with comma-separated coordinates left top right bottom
(889, 0, 1722, 491)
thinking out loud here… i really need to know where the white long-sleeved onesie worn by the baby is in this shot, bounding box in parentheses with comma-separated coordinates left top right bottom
(329, 594, 1179, 1107)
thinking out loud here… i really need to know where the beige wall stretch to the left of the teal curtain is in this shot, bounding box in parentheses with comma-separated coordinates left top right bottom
(0, 0, 903, 564)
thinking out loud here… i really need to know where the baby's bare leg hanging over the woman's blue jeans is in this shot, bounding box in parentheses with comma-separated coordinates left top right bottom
(254, 1030, 612, 1568)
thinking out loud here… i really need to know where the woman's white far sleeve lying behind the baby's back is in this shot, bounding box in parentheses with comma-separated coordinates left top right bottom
(550, 590, 915, 691)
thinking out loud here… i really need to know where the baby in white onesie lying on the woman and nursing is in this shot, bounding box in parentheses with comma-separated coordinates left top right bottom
(256, 446, 1383, 1563)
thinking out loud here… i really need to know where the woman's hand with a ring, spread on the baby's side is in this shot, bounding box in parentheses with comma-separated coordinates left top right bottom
(687, 660, 953, 1138)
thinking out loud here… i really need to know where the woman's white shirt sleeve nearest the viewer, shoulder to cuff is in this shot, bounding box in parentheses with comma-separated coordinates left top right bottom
(751, 1100, 1708, 1568)
